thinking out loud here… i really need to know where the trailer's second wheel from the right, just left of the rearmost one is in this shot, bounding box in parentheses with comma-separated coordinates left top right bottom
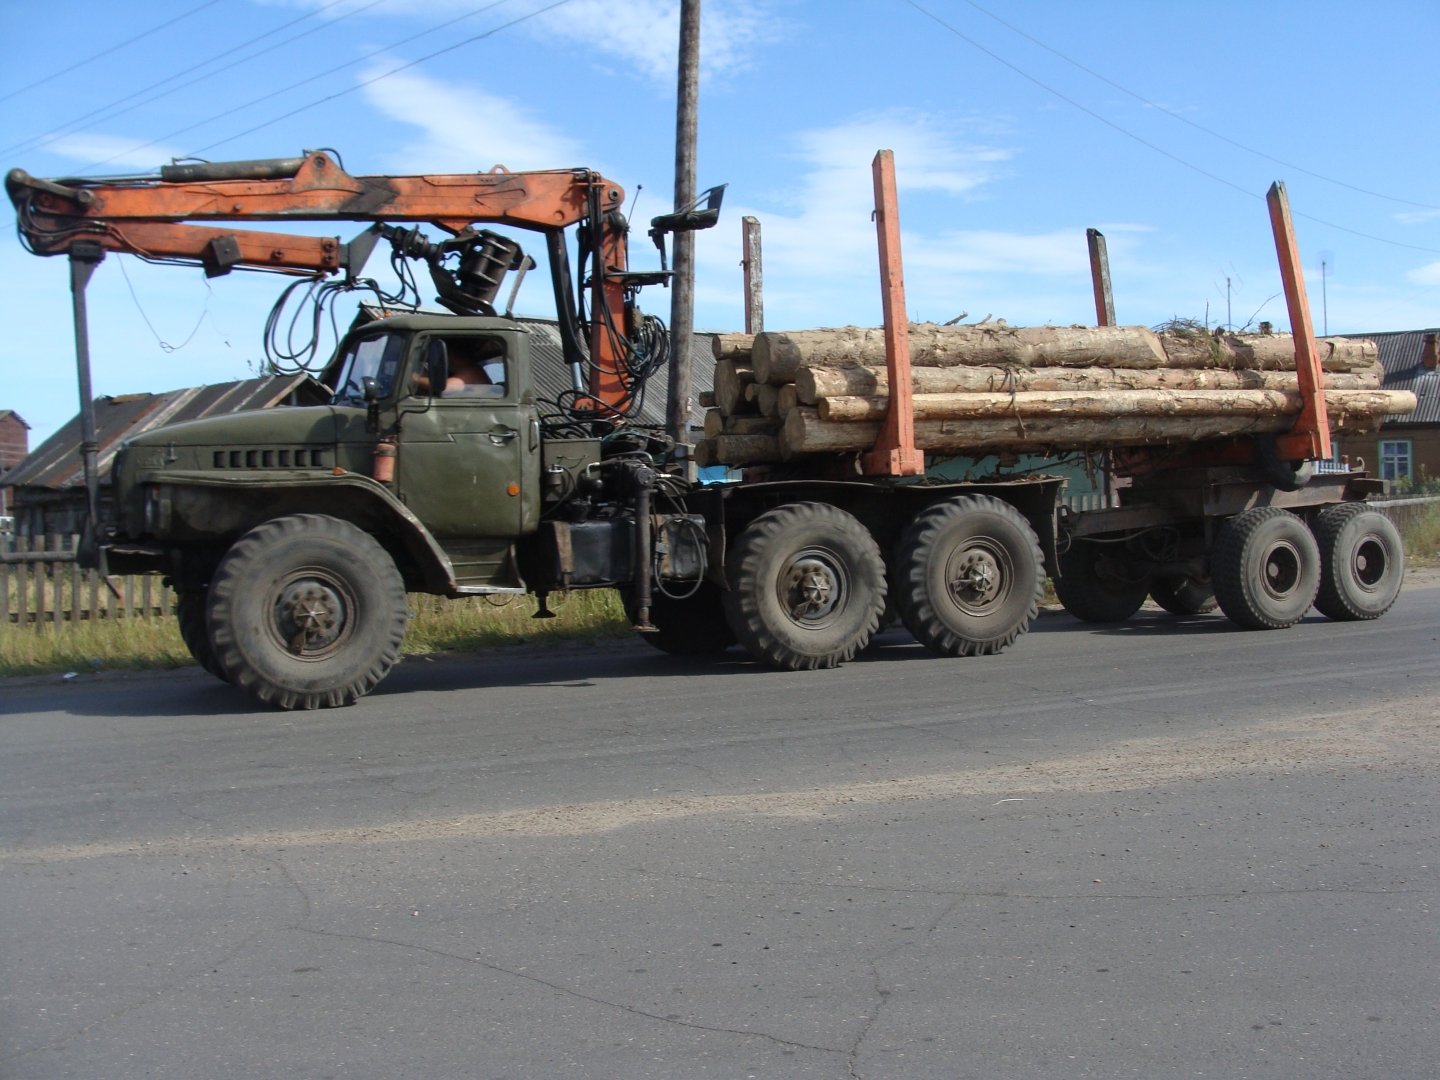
(1210, 507, 1320, 629)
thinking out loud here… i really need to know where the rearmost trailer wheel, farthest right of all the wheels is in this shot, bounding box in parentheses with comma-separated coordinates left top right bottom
(1315, 503, 1405, 622)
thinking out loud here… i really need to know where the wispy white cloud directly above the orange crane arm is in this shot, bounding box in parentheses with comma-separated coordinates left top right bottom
(364, 65, 590, 173)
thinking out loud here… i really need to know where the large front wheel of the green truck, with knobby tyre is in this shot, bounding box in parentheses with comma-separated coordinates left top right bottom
(206, 514, 408, 708)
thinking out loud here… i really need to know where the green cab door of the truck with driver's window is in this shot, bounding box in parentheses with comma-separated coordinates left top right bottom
(396, 334, 540, 588)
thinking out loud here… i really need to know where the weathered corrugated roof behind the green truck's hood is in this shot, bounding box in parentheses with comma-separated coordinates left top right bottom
(6, 374, 330, 491)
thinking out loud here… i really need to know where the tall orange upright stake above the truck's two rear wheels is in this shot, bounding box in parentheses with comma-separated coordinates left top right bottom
(861, 150, 924, 477)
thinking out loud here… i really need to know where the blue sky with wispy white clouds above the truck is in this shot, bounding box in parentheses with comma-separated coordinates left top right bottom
(0, 0, 1440, 448)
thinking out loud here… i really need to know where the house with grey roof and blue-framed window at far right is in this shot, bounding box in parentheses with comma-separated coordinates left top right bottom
(1335, 328, 1440, 484)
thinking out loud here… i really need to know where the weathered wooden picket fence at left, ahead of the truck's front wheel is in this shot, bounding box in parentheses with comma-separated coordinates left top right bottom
(0, 536, 176, 629)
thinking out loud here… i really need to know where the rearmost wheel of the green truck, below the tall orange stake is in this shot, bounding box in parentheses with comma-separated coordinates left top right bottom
(896, 495, 1044, 657)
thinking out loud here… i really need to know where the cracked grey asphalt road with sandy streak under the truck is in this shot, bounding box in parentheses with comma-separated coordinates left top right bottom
(0, 588, 1440, 1080)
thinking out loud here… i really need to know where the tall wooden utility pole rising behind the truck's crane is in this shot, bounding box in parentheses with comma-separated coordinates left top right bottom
(665, 0, 700, 444)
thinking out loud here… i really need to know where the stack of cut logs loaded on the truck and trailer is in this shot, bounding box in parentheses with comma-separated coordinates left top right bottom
(696, 324, 1416, 465)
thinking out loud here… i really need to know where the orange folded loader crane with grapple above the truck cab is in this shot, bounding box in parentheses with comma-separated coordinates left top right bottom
(6, 151, 653, 412)
